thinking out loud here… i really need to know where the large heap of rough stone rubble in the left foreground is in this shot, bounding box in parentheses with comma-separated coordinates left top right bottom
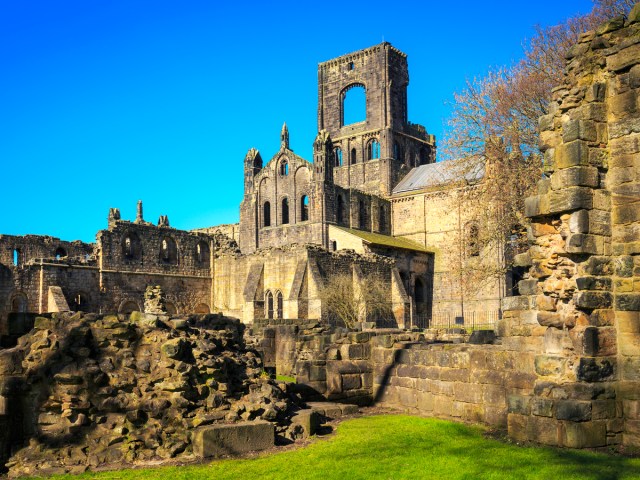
(0, 312, 301, 477)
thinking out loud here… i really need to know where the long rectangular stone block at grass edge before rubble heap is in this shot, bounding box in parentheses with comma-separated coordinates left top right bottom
(193, 421, 275, 458)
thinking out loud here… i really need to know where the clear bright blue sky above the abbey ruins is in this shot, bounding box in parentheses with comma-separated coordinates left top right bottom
(0, 0, 591, 241)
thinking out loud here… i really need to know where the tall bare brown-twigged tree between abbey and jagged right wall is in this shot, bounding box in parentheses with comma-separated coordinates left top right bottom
(442, 0, 634, 294)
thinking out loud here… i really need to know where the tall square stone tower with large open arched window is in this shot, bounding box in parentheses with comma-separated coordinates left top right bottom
(318, 42, 435, 197)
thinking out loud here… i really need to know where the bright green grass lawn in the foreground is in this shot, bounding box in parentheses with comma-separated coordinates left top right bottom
(42, 415, 640, 480)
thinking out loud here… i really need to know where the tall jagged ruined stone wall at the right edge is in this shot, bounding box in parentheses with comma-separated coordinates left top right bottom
(504, 5, 640, 446)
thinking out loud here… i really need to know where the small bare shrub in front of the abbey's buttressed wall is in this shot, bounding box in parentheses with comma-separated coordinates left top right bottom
(319, 274, 393, 328)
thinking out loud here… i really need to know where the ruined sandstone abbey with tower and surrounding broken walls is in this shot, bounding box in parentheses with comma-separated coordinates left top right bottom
(0, 4, 640, 474)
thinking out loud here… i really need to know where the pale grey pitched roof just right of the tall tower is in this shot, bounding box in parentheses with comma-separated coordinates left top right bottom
(393, 160, 484, 194)
